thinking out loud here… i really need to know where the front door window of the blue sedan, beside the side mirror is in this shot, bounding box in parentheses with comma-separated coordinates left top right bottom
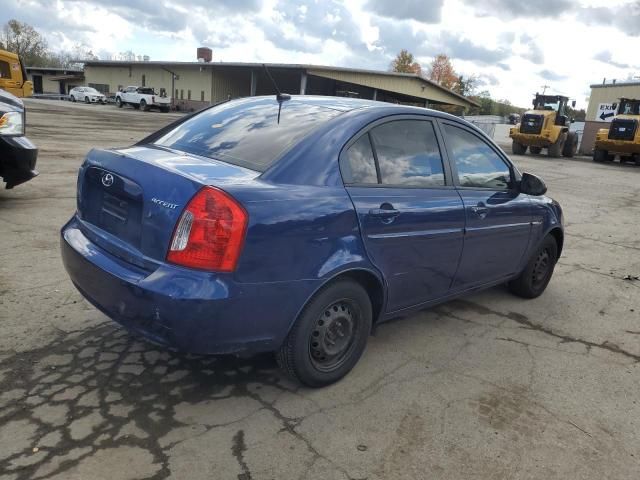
(444, 124, 511, 190)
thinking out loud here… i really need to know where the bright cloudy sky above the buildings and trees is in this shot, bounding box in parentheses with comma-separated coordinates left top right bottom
(0, 0, 640, 108)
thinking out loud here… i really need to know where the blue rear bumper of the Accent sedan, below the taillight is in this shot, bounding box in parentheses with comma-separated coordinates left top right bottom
(61, 219, 317, 354)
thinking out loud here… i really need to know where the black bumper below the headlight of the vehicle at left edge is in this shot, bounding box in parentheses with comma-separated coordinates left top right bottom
(0, 137, 38, 188)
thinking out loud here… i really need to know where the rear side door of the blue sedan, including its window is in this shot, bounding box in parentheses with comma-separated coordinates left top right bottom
(341, 116, 465, 312)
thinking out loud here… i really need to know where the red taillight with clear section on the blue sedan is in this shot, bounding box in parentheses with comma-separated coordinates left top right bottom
(167, 187, 248, 272)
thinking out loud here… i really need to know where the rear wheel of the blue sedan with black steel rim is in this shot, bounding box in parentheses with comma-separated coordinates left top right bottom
(276, 280, 372, 387)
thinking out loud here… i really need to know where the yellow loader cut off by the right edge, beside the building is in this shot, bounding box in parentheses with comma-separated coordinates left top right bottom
(593, 98, 640, 165)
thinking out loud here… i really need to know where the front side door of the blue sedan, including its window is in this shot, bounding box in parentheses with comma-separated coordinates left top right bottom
(441, 121, 532, 290)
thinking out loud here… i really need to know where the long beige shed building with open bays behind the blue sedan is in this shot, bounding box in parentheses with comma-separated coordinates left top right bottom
(84, 61, 478, 110)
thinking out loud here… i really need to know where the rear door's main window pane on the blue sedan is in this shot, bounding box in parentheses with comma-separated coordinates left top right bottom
(371, 120, 445, 187)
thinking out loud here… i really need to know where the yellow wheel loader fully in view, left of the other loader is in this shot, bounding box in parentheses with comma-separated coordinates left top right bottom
(509, 93, 578, 157)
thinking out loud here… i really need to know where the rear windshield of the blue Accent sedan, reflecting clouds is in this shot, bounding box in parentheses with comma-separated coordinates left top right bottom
(155, 97, 341, 172)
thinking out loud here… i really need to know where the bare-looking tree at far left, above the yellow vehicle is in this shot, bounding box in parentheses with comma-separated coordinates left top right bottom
(0, 20, 49, 66)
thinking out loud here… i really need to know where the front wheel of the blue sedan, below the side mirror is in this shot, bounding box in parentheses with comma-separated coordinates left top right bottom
(508, 235, 558, 298)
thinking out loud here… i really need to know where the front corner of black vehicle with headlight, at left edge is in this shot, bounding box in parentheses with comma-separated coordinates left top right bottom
(0, 90, 38, 188)
